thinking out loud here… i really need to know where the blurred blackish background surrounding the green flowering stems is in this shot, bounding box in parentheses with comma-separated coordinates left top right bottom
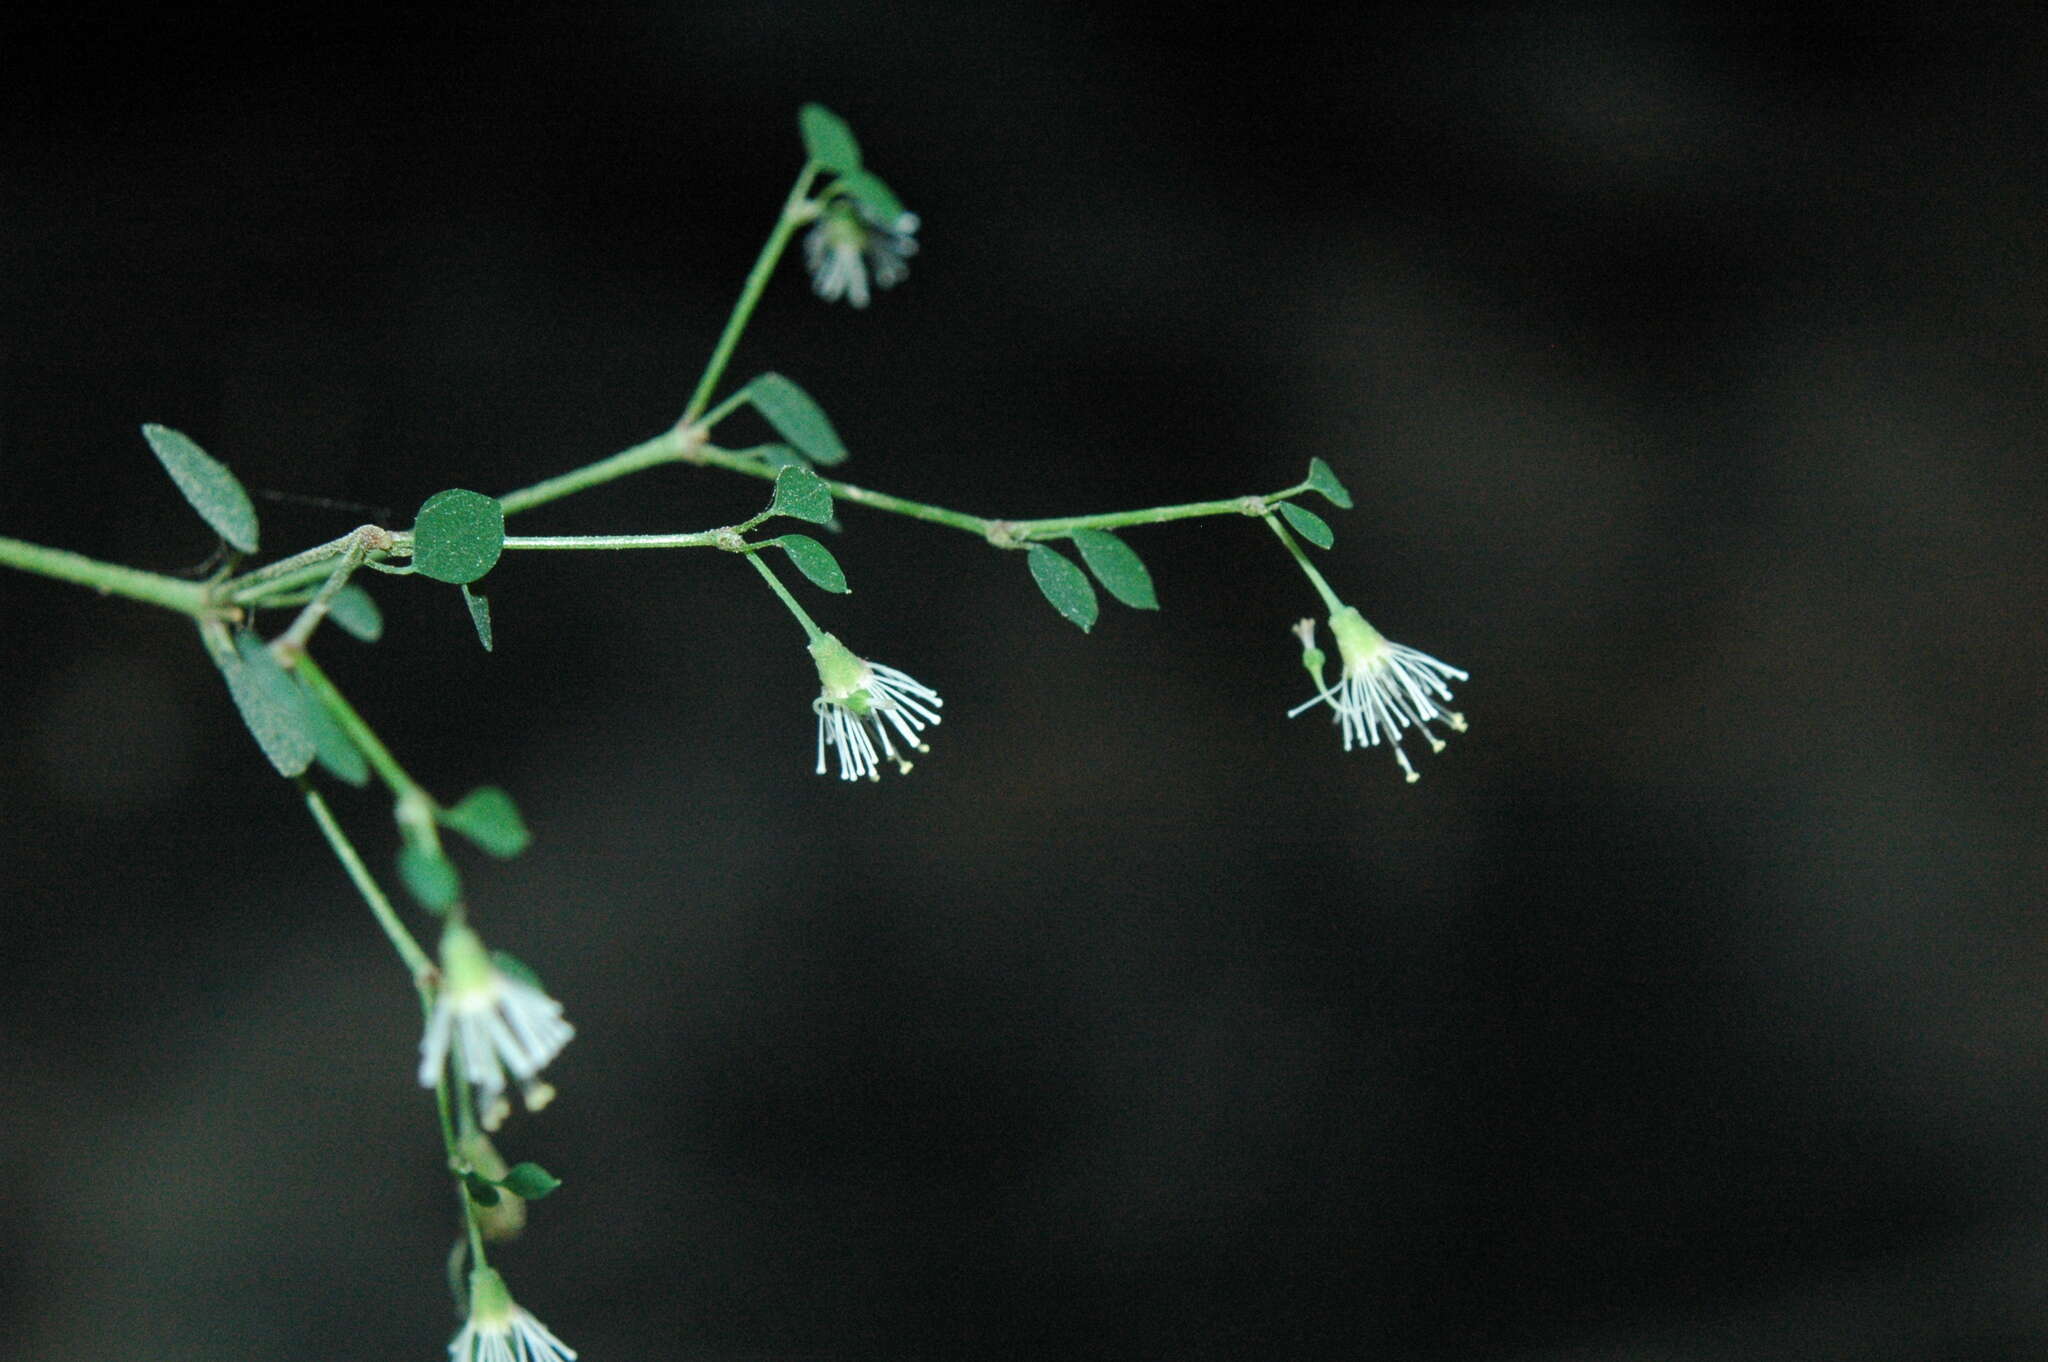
(0, 10, 2048, 1362)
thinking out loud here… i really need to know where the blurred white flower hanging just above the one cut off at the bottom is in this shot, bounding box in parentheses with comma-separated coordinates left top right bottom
(420, 926, 575, 1131)
